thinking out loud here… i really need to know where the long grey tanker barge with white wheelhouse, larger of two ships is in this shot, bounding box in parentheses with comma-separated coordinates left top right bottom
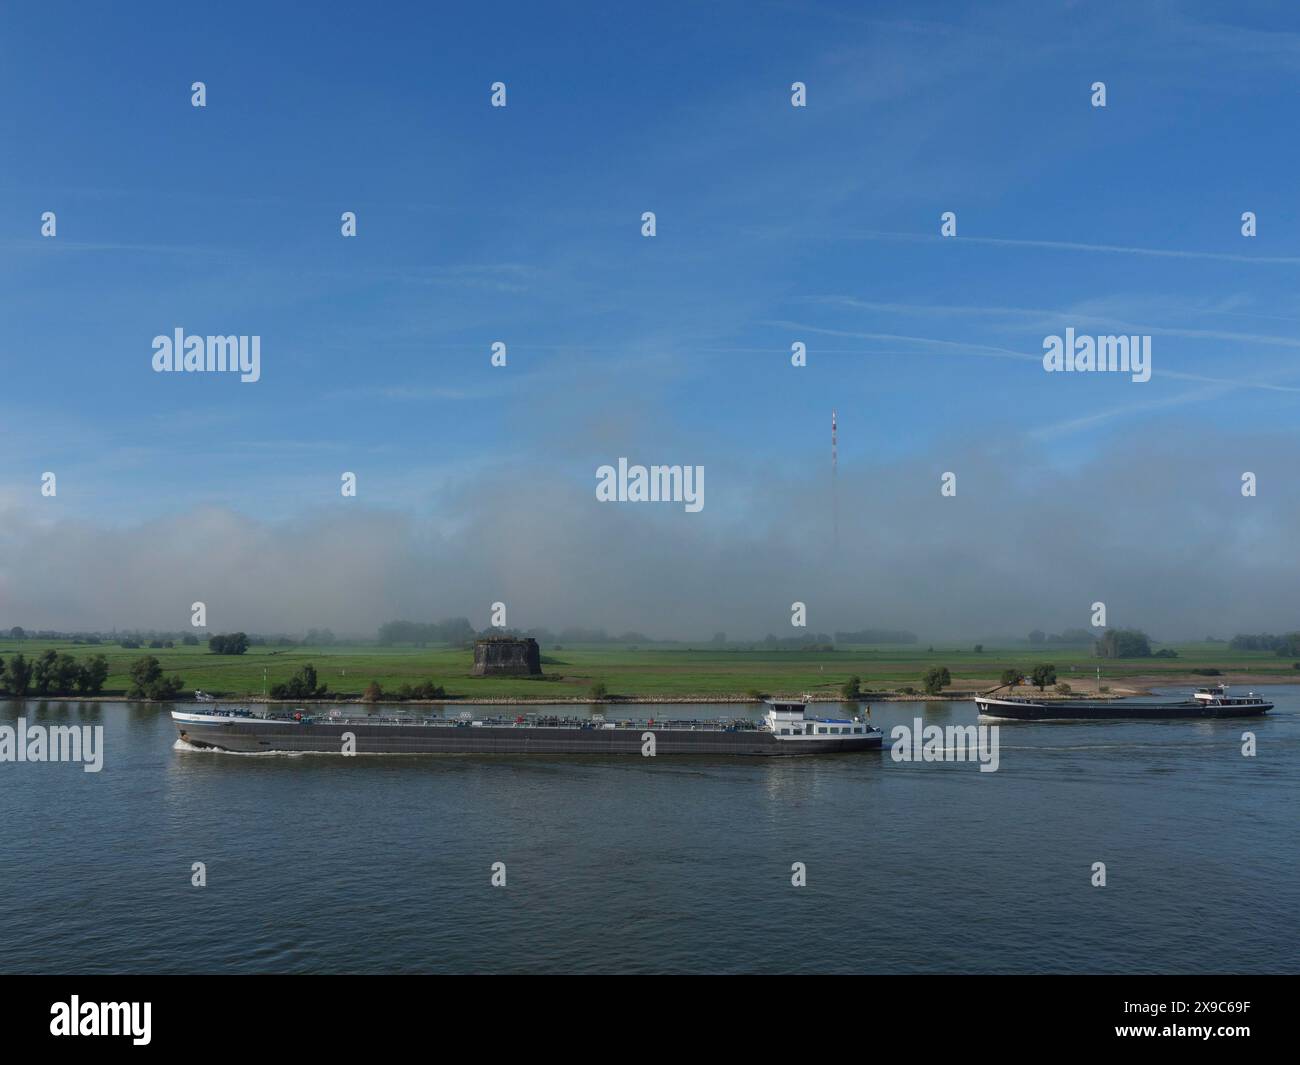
(172, 701, 883, 757)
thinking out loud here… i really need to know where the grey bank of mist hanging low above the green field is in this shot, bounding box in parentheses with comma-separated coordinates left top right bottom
(0, 416, 1300, 641)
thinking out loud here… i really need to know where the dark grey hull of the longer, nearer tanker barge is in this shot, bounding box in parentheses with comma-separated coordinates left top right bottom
(176, 718, 883, 757)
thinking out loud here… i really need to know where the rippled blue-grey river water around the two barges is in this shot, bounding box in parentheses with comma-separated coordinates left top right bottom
(0, 687, 1300, 973)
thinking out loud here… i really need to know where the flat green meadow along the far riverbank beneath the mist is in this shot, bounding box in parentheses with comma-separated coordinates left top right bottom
(0, 638, 1300, 700)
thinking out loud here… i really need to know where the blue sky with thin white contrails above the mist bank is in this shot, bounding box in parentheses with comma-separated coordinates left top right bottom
(0, 3, 1300, 627)
